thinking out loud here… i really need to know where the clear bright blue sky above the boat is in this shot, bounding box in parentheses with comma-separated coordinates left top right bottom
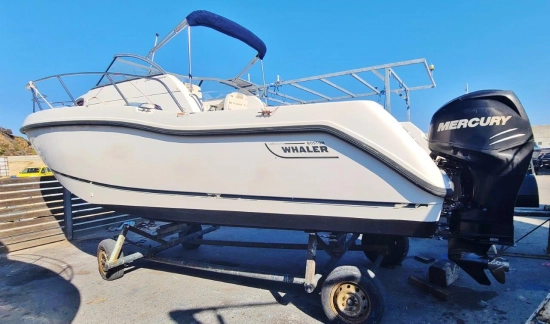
(0, 0, 550, 133)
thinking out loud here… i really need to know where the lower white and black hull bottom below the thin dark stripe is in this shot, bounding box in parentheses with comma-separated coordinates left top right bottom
(56, 173, 440, 237)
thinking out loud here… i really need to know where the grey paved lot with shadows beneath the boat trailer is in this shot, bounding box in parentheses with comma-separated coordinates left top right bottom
(0, 175, 550, 324)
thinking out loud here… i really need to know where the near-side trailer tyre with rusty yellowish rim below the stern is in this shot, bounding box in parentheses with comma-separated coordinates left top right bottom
(321, 266, 386, 324)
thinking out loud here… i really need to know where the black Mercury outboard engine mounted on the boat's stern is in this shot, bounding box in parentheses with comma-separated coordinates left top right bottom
(428, 90, 534, 285)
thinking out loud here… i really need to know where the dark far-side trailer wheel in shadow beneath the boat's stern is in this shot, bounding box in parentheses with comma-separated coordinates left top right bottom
(361, 234, 409, 266)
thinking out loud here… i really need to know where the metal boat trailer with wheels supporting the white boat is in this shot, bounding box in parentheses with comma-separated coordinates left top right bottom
(97, 223, 409, 323)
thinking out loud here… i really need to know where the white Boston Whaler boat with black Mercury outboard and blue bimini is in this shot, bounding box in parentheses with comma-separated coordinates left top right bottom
(21, 11, 533, 316)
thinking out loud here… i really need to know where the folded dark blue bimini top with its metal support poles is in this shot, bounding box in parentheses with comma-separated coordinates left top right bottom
(146, 10, 267, 84)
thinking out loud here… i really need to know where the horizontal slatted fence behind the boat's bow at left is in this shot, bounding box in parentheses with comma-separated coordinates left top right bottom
(0, 177, 137, 253)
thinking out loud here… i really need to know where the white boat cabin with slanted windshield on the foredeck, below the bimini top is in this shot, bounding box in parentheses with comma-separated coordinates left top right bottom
(76, 54, 265, 113)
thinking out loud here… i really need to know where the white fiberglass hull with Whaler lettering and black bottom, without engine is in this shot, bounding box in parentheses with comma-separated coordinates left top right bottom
(23, 101, 450, 236)
